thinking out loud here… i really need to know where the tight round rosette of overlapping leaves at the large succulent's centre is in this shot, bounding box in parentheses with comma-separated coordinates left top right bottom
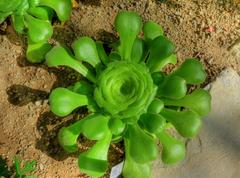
(94, 61, 156, 118)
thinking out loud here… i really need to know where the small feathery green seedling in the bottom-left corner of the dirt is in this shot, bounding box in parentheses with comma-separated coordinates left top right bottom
(13, 157, 37, 178)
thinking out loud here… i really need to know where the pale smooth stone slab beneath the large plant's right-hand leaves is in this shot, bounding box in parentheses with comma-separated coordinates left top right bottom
(152, 68, 240, 178)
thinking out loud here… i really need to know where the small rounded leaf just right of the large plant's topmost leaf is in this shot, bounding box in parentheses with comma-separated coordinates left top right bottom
(143, 21, 163, 44)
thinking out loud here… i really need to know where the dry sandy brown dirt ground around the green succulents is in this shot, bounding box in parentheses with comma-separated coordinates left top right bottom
(0, 0, 240, 178)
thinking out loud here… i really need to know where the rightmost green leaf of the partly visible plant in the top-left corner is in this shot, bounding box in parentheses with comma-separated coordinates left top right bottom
(39, 0, 72, 22)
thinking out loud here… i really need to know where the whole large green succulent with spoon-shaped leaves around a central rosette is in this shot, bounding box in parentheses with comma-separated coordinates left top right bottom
(46, 12, 211, 178)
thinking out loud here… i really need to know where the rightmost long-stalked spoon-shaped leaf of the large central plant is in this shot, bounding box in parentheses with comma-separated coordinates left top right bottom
(162, 89, 211, 116)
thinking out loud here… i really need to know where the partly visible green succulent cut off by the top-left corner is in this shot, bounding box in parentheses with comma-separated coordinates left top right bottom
(0, 0, 72, 63)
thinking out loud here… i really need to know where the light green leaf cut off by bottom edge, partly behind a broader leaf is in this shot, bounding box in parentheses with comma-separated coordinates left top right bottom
(123, 138, 151, 178)
